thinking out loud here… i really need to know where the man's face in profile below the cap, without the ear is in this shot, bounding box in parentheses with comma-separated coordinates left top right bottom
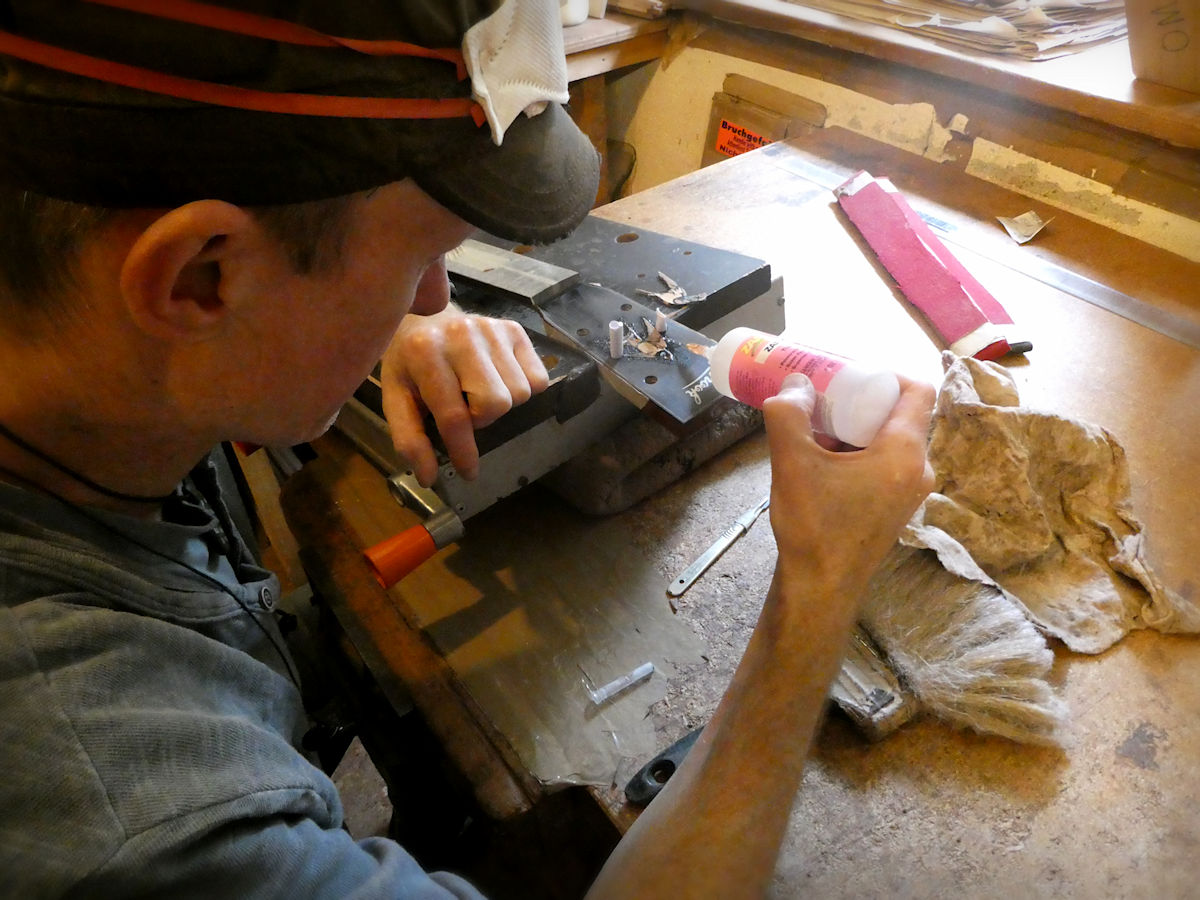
(236, 180, 475, 444)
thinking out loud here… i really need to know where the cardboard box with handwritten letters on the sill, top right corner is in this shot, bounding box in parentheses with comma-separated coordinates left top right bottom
(1126, 0, 1200, 94)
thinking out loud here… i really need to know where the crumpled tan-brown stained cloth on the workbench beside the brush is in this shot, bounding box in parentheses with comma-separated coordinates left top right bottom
(900, 353, 1200, 654)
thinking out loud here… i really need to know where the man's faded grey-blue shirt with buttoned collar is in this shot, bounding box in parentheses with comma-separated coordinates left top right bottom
(0, 460, 479, 900)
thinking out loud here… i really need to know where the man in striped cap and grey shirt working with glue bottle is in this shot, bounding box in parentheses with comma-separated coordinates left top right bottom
(0, 0, 931, 898)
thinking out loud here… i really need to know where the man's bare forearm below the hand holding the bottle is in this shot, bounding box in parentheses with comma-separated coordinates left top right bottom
(588, 574, 854, 900)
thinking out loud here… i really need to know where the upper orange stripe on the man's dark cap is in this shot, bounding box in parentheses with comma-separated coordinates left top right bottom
(84, 0, 467, 80)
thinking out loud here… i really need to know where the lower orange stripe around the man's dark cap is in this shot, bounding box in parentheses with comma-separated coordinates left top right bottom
(0, 31, 485, 126)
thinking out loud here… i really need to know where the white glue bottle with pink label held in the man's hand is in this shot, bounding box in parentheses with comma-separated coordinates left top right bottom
(708, 328, 900, 446)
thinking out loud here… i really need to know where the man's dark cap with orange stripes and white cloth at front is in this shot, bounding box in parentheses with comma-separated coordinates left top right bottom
(0, 0, 599, 242)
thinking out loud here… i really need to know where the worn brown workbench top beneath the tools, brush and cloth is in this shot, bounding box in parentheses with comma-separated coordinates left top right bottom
(286, 137, 1200, 898)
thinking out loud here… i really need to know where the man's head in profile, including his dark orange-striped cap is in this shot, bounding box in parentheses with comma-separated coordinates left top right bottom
(0, 0, 598, 453)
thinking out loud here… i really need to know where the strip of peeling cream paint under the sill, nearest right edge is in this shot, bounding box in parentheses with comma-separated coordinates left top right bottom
(966, 138, 1200, 263)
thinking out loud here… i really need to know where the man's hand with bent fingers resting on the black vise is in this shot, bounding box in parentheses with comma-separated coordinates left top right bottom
(380, 306, 550, 487)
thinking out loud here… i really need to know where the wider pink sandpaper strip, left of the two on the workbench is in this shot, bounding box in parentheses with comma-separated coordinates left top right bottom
(836, 173, 1009, 344)
